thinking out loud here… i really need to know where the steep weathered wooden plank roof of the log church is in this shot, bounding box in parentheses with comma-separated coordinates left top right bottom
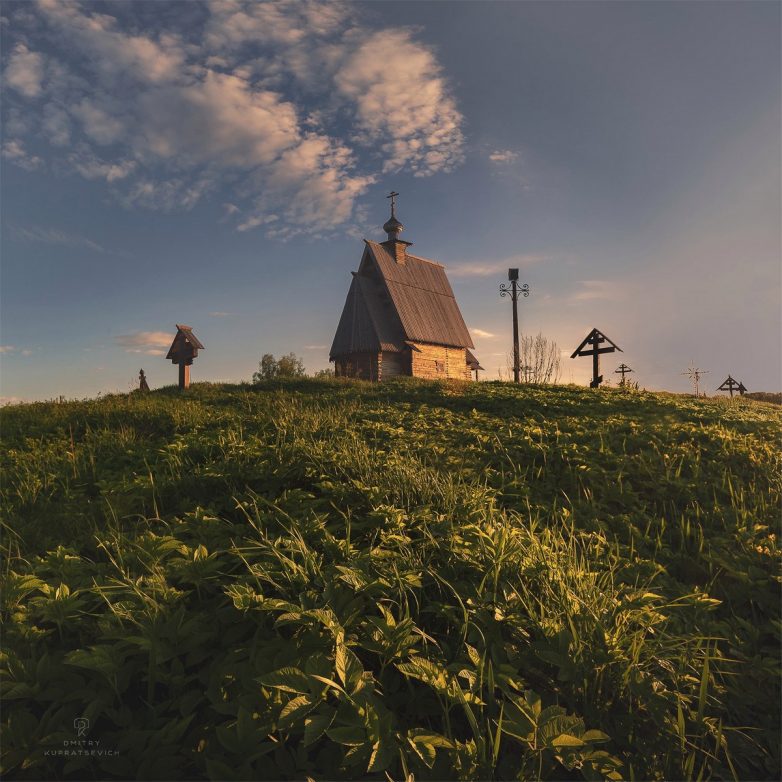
(329, 240, 473, 360)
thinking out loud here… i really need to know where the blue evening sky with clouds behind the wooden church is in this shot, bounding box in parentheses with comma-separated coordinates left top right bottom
(0, 0, 782, 402)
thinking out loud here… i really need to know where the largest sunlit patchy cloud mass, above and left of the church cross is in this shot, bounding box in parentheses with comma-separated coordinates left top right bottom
(3, 0, 464, 239)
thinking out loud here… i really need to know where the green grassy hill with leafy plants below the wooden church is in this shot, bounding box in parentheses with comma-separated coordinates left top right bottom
(0, 380, 782, 780)
